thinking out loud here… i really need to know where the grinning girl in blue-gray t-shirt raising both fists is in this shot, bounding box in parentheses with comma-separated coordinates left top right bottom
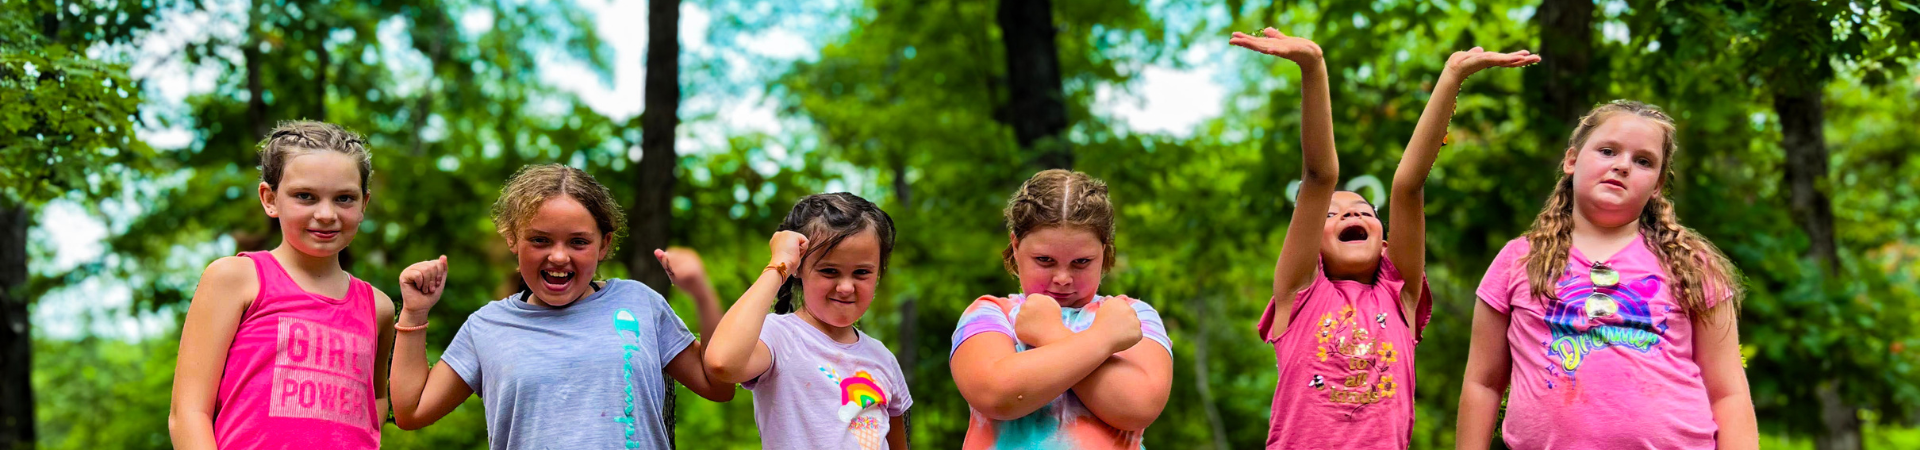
(390, 165, 733, 448)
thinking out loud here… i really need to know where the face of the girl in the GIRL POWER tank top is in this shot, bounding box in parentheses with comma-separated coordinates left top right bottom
(259, 152, 367, 258)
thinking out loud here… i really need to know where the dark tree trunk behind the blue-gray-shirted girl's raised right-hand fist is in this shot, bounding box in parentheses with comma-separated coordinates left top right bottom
(626, 0, 680, 448)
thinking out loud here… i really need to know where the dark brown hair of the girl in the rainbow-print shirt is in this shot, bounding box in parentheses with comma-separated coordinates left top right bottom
(774, 192, 893, 313)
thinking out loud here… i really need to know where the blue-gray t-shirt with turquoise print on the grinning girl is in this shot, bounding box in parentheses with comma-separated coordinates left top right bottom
(440, 279, 693, 448)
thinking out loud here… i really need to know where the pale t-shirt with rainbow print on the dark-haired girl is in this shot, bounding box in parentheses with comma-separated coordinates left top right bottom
(739, 313, 914, 450)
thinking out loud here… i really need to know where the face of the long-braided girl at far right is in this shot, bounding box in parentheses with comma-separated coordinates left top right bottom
(1561, 113, 1667, 227)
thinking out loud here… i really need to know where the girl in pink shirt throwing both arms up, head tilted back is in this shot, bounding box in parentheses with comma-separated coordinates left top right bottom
(1229, 29, 1540, 448)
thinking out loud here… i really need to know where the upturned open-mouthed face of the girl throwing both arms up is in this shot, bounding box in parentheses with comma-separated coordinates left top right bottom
(1321, 190, 1386, 279)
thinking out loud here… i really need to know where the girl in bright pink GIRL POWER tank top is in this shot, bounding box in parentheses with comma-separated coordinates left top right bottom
(167, 121, 394, 448)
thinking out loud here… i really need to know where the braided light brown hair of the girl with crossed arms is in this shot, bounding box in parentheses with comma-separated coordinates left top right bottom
(1000, 169, 1114, 277)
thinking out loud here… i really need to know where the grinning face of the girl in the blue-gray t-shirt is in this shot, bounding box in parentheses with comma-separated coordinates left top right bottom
(513, 194, 611, 306)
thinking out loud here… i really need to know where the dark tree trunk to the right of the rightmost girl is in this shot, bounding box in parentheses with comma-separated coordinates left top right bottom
(1774, 83, 1860, 450)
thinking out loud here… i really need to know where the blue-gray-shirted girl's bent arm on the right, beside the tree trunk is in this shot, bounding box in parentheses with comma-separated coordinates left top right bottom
(653, 246, 733, 402)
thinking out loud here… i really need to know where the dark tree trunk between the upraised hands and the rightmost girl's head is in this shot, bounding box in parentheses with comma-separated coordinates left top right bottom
(1523, 0, 1601, 135)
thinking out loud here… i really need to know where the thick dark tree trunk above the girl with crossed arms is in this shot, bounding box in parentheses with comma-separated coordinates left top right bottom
(998, 0, 1073, 169)
